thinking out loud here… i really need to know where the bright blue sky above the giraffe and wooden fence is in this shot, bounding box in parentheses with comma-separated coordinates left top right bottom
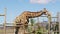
(0, 0, 60, 22)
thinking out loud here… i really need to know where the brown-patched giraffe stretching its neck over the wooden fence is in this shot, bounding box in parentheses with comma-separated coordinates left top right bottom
(15, 8, 50, 34)
